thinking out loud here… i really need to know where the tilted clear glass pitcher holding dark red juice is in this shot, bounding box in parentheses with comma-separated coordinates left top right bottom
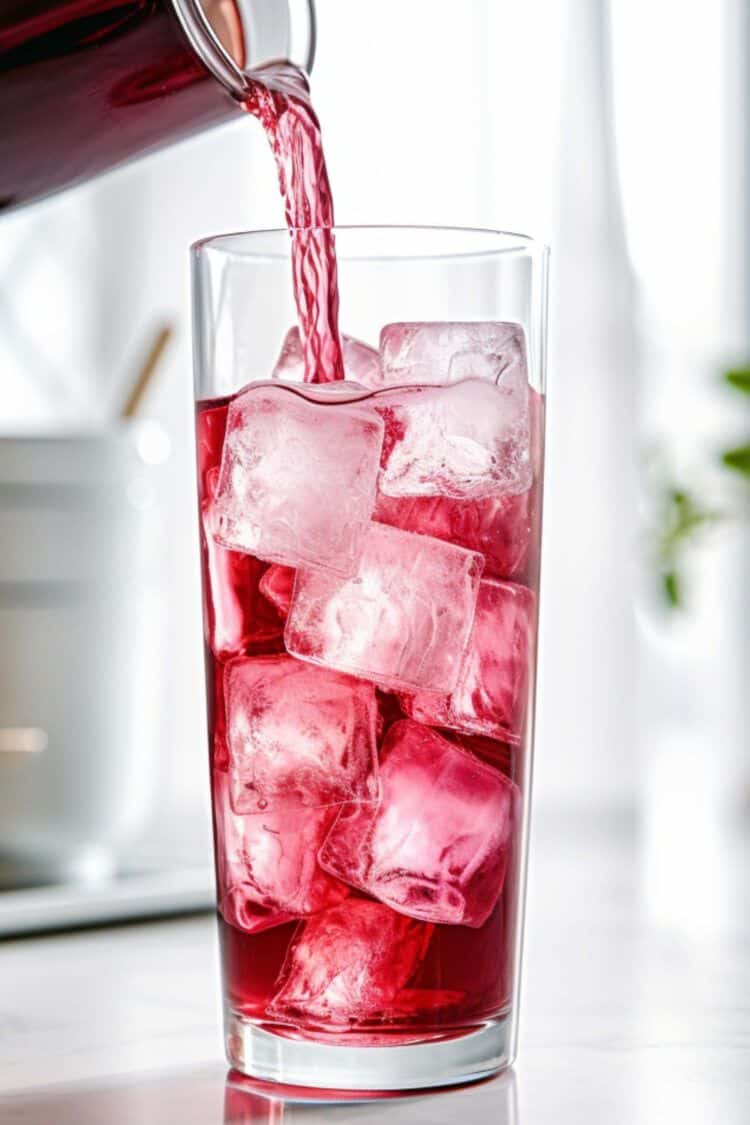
(0, 0, 315, 212)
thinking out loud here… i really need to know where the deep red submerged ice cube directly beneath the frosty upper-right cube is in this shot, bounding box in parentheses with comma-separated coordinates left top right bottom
(373, 492, 532, 590)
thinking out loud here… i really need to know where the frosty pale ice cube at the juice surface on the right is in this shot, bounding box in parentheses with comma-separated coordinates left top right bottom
(374, 379, 532, 500)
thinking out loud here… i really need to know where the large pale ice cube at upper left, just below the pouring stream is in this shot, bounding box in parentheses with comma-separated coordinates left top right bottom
(216, 384, 382, 576)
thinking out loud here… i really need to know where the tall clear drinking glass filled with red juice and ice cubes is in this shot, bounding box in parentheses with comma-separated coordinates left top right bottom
(193, 227, 548, 1090)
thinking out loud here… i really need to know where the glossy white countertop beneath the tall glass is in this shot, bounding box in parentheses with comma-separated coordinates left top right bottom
(0, 817, 750, 1125)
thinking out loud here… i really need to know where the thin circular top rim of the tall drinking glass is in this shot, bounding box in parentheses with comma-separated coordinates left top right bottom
(190, 223, 550, 263)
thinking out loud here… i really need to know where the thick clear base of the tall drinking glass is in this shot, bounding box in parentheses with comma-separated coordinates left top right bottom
(225, 1011, 513, 1091)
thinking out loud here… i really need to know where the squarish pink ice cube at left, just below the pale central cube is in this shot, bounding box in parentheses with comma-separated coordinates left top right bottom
(224, 656, 378, 813)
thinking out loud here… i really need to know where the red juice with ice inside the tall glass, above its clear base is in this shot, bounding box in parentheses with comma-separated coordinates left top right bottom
(197, 324, 542, 1071)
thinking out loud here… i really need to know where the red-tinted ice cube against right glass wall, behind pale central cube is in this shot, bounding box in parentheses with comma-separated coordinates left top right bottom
(401, 579, 535, 745)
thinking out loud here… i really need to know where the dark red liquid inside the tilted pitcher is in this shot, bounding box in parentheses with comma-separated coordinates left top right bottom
(0, 0, 242, 209)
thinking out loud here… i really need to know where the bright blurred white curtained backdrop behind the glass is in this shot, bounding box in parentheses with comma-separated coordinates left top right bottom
(0, 0, 750, 895)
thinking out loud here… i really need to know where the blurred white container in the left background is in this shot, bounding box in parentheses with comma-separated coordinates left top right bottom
(0, 421, 169, 886)
